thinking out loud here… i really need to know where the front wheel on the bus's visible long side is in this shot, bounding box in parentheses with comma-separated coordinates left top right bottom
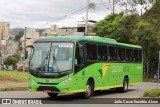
(81, 80, 94, 99)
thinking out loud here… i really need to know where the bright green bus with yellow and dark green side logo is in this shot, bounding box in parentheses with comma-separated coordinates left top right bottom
(28, 36, 143, 98)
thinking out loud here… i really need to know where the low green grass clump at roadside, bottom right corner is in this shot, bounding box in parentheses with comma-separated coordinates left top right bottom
(143, 89, 160, 97)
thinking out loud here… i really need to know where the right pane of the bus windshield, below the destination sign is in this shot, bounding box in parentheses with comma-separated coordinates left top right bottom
(49, 43, 73, 72)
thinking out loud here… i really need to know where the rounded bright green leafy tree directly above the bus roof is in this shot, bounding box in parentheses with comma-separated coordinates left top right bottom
(95, 13, 140, 43)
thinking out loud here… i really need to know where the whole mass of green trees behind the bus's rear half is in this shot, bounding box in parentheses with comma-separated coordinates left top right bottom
(95, 0, 160, 78)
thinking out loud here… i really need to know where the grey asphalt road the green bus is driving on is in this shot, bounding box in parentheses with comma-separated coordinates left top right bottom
(0, 82, 160, 107)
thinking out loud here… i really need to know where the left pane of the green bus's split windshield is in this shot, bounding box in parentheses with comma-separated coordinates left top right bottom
(30, 43, 51, 71)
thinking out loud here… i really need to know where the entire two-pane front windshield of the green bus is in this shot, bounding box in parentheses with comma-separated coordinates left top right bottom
(30, 42, 74, 73)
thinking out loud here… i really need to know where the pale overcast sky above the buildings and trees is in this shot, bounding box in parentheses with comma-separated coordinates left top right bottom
(0, 0, 148, 28)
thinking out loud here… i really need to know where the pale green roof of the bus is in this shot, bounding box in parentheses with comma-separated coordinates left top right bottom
(35, 36, 142, 48)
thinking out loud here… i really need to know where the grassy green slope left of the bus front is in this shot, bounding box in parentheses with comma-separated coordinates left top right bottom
(0, 71, 28, 83)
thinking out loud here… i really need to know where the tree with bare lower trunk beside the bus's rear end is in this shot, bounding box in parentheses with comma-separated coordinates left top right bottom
(133, 21, 158, 78)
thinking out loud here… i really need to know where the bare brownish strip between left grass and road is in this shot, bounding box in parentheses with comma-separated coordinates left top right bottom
(0, 82, 28, 91)
